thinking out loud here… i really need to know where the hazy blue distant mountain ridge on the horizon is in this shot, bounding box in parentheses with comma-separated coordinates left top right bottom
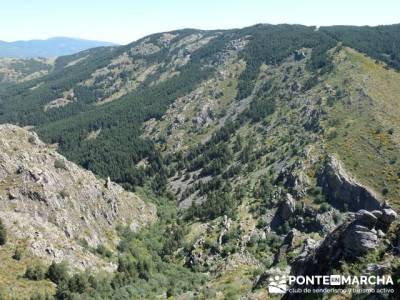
(0, 37, 116, 58)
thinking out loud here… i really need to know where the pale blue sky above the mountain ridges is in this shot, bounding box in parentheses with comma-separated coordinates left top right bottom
(0, 0, 400, 44)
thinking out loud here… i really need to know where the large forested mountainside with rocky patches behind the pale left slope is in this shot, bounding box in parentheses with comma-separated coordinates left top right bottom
(0, 25, 400, 299)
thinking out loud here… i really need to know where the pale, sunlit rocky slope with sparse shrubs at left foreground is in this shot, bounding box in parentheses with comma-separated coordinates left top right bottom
(0, 125, 156, 268)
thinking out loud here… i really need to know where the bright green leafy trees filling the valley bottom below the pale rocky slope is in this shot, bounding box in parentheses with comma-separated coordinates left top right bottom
(38, 191, 205, 299)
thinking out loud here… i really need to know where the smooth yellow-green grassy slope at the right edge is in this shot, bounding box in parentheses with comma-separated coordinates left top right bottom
(325, 48, 400, 204)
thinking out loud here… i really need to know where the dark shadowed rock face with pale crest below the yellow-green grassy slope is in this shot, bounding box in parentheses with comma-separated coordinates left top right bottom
(318, 156, 381, 211)
